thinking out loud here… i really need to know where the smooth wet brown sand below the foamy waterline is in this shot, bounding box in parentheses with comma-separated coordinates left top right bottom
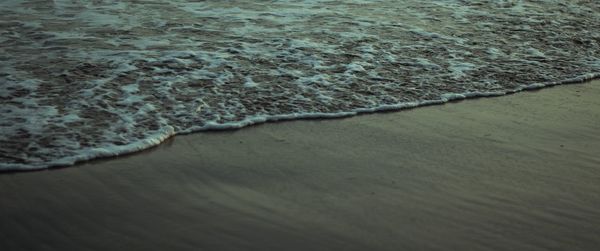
(0, 81, 600, 250)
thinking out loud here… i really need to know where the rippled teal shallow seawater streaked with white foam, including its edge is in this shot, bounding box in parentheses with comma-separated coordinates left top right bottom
(0, 0, 600, 170)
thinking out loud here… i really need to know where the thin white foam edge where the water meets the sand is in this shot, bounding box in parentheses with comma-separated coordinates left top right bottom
(0, 73, 600, 172)
